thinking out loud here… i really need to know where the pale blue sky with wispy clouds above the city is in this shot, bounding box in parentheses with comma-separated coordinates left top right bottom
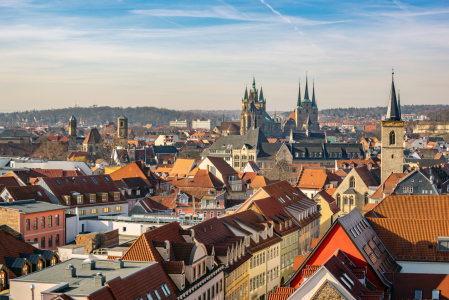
(0, 0, 449, 111)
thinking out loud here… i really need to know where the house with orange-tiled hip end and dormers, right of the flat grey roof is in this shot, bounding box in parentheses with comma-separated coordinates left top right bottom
(122, 222, 224, 300)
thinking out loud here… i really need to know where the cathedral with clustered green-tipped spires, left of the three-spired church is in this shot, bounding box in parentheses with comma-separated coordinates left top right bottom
(240, 77, 282, 137)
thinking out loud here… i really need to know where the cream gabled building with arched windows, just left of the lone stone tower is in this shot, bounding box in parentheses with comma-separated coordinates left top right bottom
(332, 164, 380, 214)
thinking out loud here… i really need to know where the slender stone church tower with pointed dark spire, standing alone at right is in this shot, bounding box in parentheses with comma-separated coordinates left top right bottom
(381, 73, 405, 182)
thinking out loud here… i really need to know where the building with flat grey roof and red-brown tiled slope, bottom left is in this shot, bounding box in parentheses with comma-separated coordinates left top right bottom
(10, 258, 178, 300)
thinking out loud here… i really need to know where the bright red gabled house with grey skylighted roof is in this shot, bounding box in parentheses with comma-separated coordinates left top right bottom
(286, 209, 401, 292)
